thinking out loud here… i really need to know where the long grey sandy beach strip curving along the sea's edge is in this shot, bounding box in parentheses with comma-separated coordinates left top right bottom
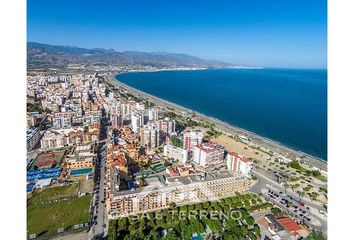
(108, 73, 327, 172)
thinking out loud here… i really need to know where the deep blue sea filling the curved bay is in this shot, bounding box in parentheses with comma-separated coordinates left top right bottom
(116, 69, 327, 160)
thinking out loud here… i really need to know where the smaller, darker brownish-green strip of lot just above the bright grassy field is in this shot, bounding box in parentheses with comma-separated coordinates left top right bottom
(29, 184, 79, 204)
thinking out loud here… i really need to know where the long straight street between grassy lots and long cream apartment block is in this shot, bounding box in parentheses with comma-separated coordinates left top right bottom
(89, 113, 108, 239)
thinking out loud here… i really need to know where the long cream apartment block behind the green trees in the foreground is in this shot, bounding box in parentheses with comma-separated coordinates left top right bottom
(107, 170, 249, 219)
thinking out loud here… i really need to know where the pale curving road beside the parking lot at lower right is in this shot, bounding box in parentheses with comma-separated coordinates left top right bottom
(250, 171, 327, 235)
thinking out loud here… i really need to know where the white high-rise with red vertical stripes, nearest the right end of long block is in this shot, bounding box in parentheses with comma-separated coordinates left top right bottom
(226, 152, 253, 175)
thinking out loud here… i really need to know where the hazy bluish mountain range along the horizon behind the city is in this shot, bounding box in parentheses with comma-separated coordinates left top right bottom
(27, 42, 233, 69)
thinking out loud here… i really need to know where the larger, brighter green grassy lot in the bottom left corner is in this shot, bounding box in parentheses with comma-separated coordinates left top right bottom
(27, 196, 91, 236)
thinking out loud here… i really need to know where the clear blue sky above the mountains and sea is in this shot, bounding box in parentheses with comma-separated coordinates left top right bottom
(27, 0, 327, 68)
